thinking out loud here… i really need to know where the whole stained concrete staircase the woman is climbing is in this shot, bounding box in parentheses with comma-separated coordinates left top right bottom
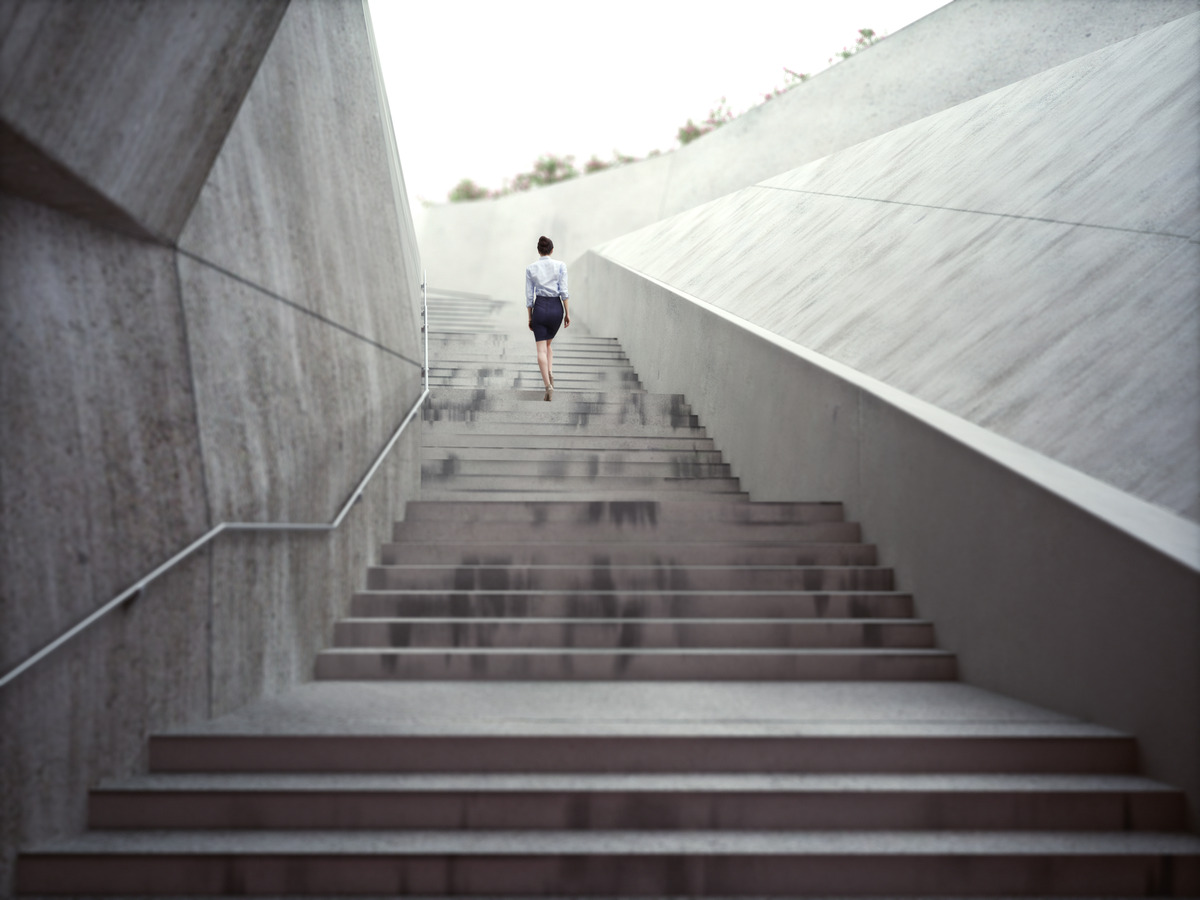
(18, 298, 1200, 898)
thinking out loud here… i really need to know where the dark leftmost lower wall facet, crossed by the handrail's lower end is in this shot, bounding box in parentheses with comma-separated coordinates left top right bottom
(0, 194, 211, 895)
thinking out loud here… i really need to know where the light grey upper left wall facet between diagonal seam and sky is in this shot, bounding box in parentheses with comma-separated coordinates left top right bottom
(179, 0, 421, 360)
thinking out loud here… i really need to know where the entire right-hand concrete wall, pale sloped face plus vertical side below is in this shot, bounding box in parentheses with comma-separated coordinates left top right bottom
(575, 13, 1200, 812)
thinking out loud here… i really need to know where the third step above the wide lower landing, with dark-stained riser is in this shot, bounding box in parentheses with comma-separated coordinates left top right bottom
(350, 590, 913, 619)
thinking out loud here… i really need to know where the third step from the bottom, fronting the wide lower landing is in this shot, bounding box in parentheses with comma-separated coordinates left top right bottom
(149, 729, 1138, 775)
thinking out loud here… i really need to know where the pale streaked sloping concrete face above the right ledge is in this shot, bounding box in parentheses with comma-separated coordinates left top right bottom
(590, 13, 1200, 521)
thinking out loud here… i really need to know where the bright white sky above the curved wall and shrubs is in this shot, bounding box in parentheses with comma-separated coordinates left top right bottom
(371, 0, 948, 206)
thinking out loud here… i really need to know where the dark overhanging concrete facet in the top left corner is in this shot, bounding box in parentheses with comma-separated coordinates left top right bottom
(0, 0, 288, 242)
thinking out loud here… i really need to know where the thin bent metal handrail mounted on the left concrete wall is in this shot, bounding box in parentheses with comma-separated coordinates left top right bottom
(0, 270, 430, 688)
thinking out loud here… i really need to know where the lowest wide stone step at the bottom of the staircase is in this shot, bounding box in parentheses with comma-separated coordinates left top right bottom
(17, 830, 1200, 898)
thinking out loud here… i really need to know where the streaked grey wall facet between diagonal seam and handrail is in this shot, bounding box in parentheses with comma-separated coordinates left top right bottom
(179, 257, 420, 522)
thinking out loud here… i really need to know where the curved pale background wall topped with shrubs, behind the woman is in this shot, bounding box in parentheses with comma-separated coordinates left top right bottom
(419, 0, 1200, 308)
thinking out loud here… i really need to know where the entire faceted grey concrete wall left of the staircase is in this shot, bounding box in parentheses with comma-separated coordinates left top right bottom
(0, 0, 420, 893)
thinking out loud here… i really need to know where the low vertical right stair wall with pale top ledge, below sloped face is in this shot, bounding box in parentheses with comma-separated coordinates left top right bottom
(580, 252, 1200, 830)
